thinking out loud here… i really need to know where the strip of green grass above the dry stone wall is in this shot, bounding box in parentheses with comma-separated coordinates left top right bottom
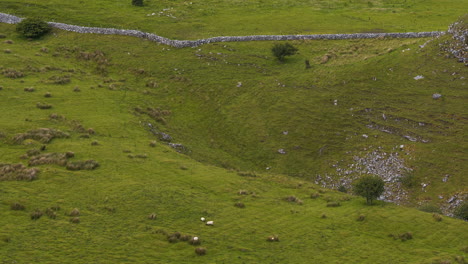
(0, 0, 466, 39)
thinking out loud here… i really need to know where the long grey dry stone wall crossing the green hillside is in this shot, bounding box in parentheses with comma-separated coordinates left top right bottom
(0, 13, 443, 48)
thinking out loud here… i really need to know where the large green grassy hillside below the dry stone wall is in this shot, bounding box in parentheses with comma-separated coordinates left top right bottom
(0, 11, 468, 263)
